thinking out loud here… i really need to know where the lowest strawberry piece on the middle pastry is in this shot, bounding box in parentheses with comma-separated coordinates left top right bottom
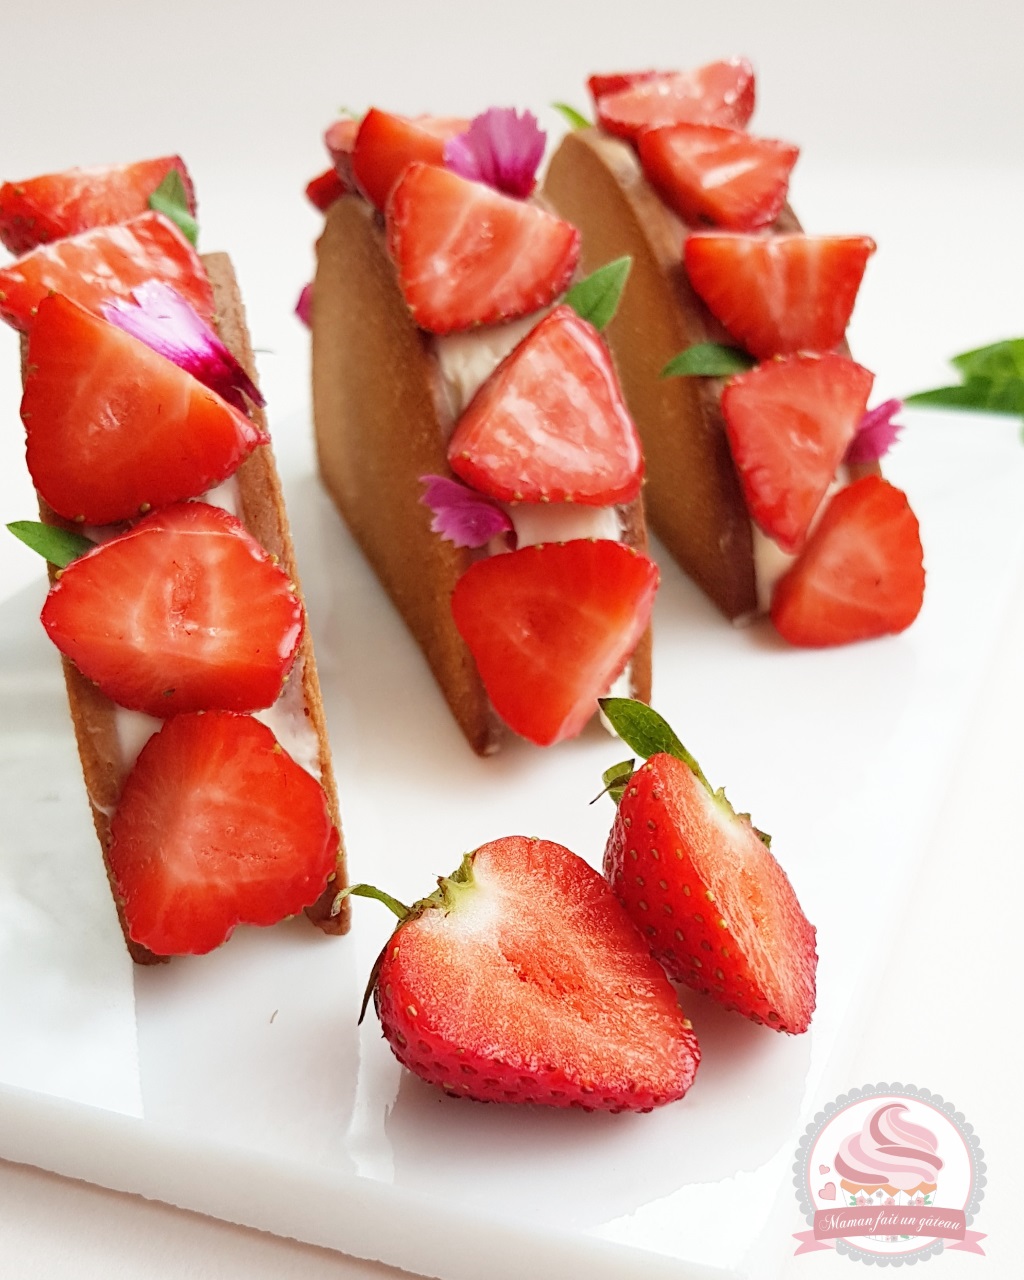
(452, 539, 658, 746)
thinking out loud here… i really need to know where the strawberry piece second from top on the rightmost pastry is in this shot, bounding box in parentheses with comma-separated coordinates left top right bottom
(637, 124, 800, 230)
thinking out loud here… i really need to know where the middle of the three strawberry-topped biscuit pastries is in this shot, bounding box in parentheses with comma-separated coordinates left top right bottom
(310, 109, 658, 754)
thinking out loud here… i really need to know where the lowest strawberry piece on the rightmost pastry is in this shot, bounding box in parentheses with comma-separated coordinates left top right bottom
(772, 475, 924, 648)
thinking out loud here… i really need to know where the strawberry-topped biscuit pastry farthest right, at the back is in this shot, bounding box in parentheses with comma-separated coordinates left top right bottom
(544, 59, 924, 645)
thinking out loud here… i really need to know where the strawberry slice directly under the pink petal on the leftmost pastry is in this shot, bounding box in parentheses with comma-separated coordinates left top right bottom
(22, 293, 268, 525)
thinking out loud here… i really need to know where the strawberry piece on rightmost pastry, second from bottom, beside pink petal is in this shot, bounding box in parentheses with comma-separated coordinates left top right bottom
(722, 353, 874, 552)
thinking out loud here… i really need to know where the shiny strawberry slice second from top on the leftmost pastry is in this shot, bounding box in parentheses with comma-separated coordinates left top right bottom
(0, 212, 214, 330)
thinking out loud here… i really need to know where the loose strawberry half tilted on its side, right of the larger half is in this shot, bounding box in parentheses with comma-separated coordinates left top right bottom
(602, 698, 818, 1034)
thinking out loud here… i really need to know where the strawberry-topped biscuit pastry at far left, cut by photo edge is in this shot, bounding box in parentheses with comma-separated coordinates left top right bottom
(0, 157, 347, 963)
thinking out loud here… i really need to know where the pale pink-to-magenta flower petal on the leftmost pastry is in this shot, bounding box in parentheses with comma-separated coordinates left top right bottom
(102, 280, 266, 413)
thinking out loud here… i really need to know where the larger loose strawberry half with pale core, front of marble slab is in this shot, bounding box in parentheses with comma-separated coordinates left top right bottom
(348, 836, 700, 1111)
